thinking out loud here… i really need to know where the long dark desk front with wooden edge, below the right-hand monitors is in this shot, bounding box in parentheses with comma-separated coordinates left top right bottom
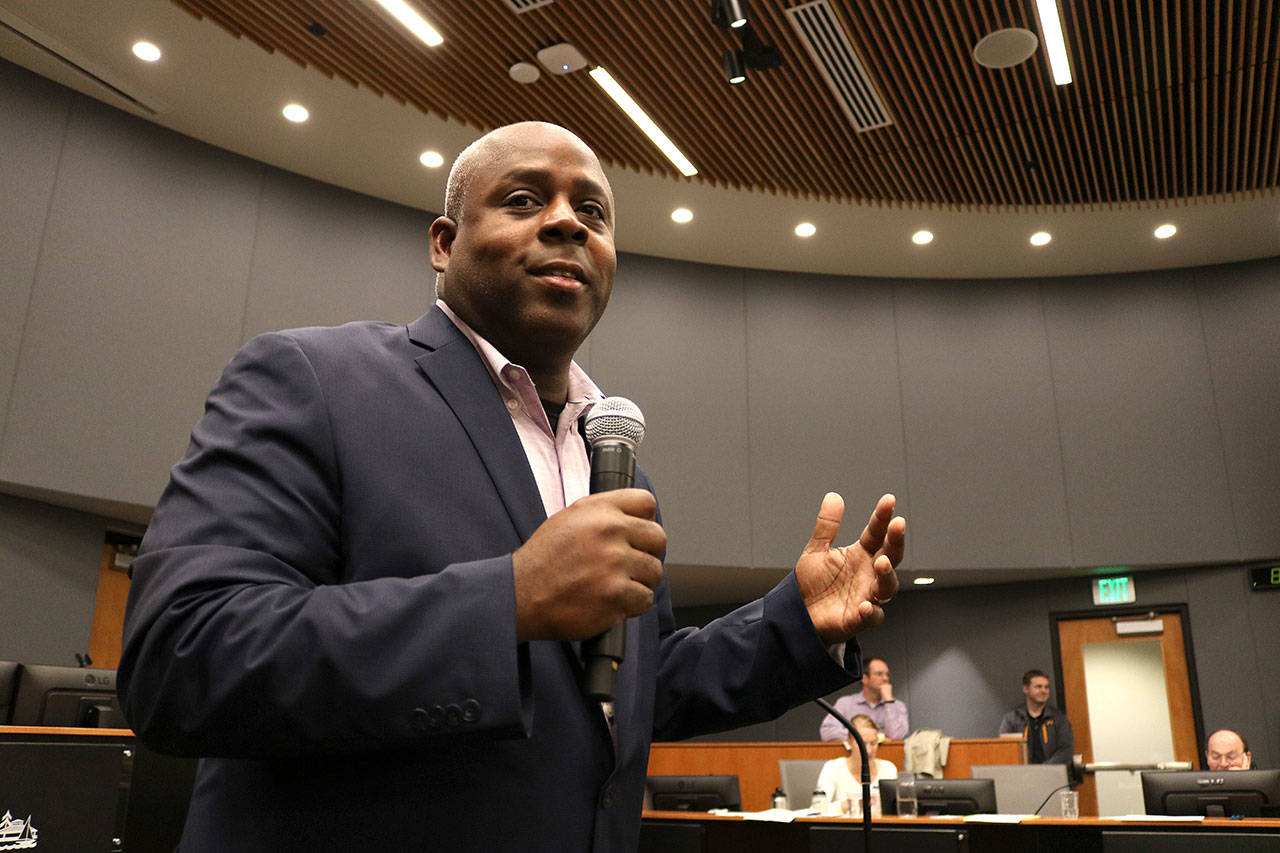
(640, 812, 1280, 853)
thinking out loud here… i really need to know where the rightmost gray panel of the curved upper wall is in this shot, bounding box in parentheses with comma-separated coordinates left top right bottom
(1194, 260, 1280, 558)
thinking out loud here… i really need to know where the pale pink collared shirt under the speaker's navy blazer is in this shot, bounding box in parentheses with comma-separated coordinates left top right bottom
(435, 300, 604, 517)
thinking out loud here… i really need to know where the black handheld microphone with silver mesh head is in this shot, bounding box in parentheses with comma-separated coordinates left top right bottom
(582, 397, 644, 702)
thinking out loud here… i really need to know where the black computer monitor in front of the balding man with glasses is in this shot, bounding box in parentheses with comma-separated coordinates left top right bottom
(1142, 770, 1280, 817)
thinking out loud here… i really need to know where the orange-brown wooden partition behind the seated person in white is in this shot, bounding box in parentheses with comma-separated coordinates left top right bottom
(649, 738, 1023, 812)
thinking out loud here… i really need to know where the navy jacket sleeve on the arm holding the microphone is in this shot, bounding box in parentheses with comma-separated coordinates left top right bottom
(119, 333, 531, 757)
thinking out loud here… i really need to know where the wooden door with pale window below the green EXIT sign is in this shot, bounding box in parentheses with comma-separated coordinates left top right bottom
(1057, 612, 1199, 816)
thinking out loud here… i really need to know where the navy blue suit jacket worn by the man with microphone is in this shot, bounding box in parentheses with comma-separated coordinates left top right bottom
(119, 302, 860, 853)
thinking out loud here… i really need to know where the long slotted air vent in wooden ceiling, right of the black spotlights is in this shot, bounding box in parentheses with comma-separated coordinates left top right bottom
(778, 0, 893, 132)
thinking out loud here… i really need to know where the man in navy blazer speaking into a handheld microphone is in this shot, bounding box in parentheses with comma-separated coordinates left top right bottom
(119, 123, 905, 853)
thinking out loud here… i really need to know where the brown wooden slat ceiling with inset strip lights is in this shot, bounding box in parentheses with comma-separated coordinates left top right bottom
(173, 0, 1280, 209)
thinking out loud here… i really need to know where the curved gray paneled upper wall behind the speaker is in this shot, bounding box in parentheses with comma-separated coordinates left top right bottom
(0, 63, 1280, 573)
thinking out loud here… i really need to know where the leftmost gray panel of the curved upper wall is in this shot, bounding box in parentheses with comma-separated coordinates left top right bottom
(0, 60, 70, 446)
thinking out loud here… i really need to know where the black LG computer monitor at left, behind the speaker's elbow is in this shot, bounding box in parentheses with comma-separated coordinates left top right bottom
(12, 663, 128, 729)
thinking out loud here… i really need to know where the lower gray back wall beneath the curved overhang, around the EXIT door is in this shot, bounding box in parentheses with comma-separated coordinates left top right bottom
(676, 566, 1280, 753)
